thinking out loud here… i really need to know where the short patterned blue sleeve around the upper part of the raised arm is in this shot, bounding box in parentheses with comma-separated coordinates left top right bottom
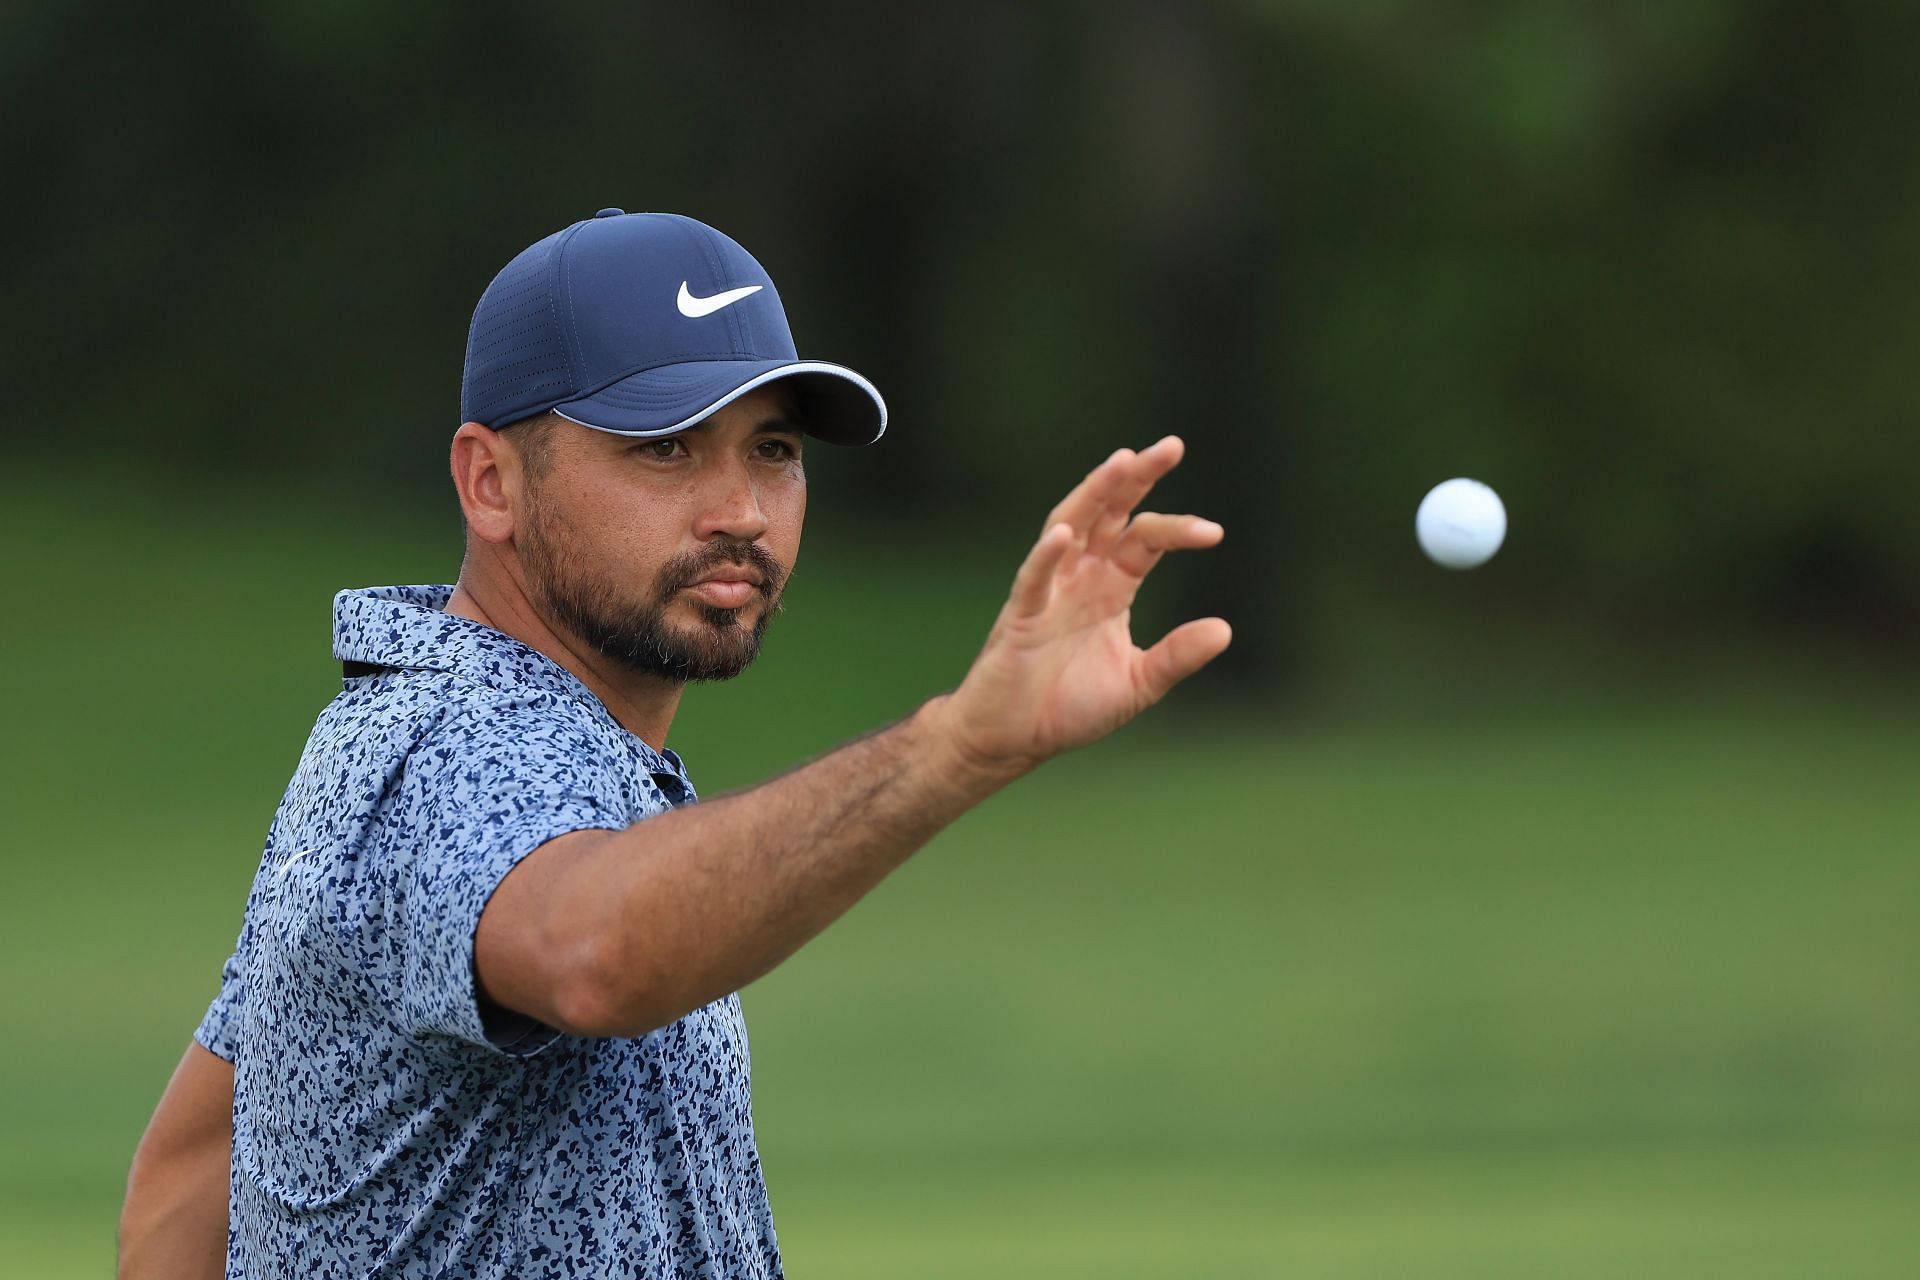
(396, 702, 630, 1055)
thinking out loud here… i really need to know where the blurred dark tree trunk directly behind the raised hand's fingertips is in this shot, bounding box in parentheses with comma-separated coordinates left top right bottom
(1087, 0, 1304, 695)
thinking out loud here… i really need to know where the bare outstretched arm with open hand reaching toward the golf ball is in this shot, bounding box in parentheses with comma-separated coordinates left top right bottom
(474, 436, 1231, 1036)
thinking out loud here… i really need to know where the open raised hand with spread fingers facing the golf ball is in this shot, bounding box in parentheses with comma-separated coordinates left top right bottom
(937, 436, 1233, 775)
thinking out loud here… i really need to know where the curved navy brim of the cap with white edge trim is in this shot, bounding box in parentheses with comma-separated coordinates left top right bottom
(553, 361, 887, 445)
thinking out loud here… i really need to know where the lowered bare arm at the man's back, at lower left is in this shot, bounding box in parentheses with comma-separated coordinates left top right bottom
(119, 1044, 234, 1280)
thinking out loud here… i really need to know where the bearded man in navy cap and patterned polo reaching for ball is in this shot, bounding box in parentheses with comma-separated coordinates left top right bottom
(121, 209, 1229, 1280)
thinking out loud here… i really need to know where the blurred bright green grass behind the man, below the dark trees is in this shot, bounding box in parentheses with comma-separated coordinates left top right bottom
(0, 468, 1920, 1278)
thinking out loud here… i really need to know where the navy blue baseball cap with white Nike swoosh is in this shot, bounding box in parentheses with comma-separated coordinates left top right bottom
(461, 209, 887, 445)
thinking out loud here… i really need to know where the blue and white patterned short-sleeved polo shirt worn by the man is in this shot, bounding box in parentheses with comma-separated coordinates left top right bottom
(196, 587, 781, 1280)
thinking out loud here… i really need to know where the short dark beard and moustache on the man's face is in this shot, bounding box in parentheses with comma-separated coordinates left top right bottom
(520, 503, 787, 683)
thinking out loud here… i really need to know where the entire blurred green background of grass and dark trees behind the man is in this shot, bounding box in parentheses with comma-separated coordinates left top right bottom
(0, 0, 1920, 1276)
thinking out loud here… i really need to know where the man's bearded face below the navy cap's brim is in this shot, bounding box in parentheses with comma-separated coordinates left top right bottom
(515, 384, 806, 683)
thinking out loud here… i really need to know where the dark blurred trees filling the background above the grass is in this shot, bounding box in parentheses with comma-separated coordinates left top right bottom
(0, 0, 1920, 667)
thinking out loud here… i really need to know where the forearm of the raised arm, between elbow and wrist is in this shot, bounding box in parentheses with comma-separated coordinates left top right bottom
(555, 699, 1016, 1034)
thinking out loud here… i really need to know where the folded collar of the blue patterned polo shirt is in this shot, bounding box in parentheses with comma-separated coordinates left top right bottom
(334, 585, 685, 781)
